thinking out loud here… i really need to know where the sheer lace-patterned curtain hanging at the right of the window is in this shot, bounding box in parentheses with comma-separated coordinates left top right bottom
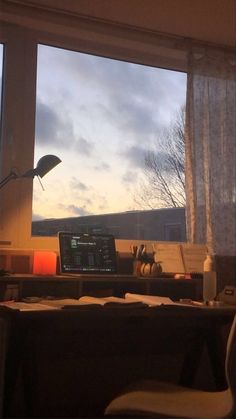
(185, 49, 236, 256)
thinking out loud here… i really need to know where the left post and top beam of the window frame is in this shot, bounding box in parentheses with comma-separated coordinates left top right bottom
(0, 18, 187, 249)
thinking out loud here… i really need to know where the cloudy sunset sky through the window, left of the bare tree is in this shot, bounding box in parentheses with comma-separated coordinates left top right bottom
(0, 45, 186, 220)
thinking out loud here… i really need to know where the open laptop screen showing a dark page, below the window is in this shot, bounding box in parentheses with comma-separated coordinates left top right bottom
(58, 232, 117, 274)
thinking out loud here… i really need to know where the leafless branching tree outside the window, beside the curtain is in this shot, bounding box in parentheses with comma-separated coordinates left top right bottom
(134, 107, 186, 209)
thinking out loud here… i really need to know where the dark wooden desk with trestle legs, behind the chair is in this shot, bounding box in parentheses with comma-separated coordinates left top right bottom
(0, 306, 234, 418)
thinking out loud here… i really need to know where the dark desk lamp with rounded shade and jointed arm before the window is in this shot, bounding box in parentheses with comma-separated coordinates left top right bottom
(0, 154, 61, 189)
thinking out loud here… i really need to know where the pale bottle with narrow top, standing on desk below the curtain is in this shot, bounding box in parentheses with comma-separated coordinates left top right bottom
(203, 254, 217, 302)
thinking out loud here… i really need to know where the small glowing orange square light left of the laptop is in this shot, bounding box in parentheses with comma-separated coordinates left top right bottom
(33, 251, 57, 275)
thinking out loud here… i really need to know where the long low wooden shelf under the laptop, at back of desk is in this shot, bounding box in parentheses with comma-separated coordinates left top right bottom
(0, 274, 202, 300)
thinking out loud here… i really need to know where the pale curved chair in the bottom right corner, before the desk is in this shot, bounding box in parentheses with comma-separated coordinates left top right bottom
(105, 315, 236, 419)
